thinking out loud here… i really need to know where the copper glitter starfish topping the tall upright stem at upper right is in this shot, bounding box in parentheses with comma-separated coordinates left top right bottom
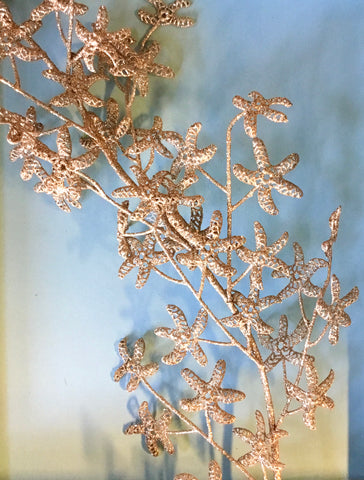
(233, 92, 292, 138)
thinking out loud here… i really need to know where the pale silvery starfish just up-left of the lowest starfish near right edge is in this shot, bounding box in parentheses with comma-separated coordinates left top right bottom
(258, 315, 314, 372)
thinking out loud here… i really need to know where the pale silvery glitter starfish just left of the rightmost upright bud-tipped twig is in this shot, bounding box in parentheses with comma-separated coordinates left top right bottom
(272, 242, 327, 301)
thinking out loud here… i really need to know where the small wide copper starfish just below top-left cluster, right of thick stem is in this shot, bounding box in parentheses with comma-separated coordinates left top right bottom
(125, 117, 182, 158)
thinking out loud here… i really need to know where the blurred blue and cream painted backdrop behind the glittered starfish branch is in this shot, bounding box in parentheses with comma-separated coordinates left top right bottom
(0, 0, 364, 480)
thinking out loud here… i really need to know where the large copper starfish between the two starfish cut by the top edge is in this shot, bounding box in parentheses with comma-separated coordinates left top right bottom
(75, 6, 134, 75)
